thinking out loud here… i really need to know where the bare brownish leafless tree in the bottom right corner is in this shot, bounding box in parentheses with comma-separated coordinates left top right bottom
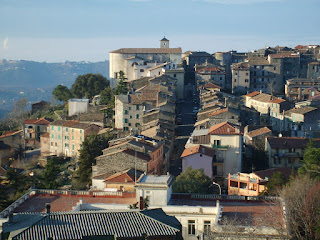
(280, 175, 320, 239)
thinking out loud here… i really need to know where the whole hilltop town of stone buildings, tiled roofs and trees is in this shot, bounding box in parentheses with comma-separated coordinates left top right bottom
(0, 37, 320, 240)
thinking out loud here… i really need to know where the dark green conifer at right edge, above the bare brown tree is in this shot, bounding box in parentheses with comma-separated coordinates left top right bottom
(298, 142, 320, 180)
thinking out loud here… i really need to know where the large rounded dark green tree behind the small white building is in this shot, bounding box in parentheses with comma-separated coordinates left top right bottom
(71, 73, 110, 99)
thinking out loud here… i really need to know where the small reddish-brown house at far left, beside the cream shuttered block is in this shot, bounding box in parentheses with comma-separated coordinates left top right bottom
(23, 118, 53, 149)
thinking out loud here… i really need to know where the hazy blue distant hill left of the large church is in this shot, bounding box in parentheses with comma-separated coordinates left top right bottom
(0, 60, 109, 118)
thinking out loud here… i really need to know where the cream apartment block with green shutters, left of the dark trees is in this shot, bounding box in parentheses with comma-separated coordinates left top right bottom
(48, 120, 100, 157)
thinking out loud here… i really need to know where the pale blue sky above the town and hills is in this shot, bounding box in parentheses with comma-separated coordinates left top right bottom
(0, 0, 320, 62)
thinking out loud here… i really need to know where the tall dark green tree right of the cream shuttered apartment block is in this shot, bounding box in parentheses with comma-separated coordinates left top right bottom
(77, 134, 112, 187)
